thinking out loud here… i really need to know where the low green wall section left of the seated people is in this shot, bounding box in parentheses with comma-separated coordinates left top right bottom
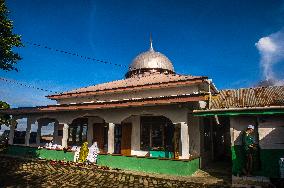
(6, 145, 74, 161)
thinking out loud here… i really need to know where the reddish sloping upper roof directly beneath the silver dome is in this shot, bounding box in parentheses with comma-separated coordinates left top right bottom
(47, 74, 207, 99)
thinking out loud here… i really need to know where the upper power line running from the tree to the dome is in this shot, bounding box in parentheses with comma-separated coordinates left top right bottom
(25, 42, 128, 68)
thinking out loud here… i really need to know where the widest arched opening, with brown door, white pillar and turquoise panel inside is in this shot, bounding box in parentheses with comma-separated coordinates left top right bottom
(114, 115, 180, 158)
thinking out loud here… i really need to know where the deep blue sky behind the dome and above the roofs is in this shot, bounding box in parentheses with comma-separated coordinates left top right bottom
(0, 0, 284, 107)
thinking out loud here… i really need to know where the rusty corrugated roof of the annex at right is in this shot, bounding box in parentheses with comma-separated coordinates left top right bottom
(211, 86, 284, 109)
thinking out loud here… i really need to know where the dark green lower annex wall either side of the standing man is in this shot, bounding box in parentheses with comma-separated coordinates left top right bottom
(232, 145, 284, 178)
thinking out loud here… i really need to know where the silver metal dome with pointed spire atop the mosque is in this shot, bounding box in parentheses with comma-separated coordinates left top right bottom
(126, 37, 174, 77)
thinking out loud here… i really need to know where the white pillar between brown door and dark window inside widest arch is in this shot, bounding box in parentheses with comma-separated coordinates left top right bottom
(131, 116, 140, 155)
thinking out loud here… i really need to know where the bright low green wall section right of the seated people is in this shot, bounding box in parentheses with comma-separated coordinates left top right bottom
(97, 155, 199, 176)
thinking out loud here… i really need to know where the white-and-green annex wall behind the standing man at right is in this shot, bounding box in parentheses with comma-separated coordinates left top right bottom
(231, 115, 284, 178)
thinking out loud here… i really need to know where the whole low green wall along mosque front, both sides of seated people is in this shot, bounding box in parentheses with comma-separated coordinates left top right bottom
(6, 145, 200, 176)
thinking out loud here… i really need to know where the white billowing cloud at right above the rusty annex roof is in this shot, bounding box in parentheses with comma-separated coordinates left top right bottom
(255, 30, 284, 85)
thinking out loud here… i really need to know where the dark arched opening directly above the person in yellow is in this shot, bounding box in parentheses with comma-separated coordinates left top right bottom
(67, 118, 88, 146)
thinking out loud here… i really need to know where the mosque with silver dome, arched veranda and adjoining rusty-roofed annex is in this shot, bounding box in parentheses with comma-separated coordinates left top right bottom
(2, 40, 284, 179)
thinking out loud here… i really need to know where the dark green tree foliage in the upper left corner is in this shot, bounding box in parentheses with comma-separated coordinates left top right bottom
(0, 0, 23, 71)
